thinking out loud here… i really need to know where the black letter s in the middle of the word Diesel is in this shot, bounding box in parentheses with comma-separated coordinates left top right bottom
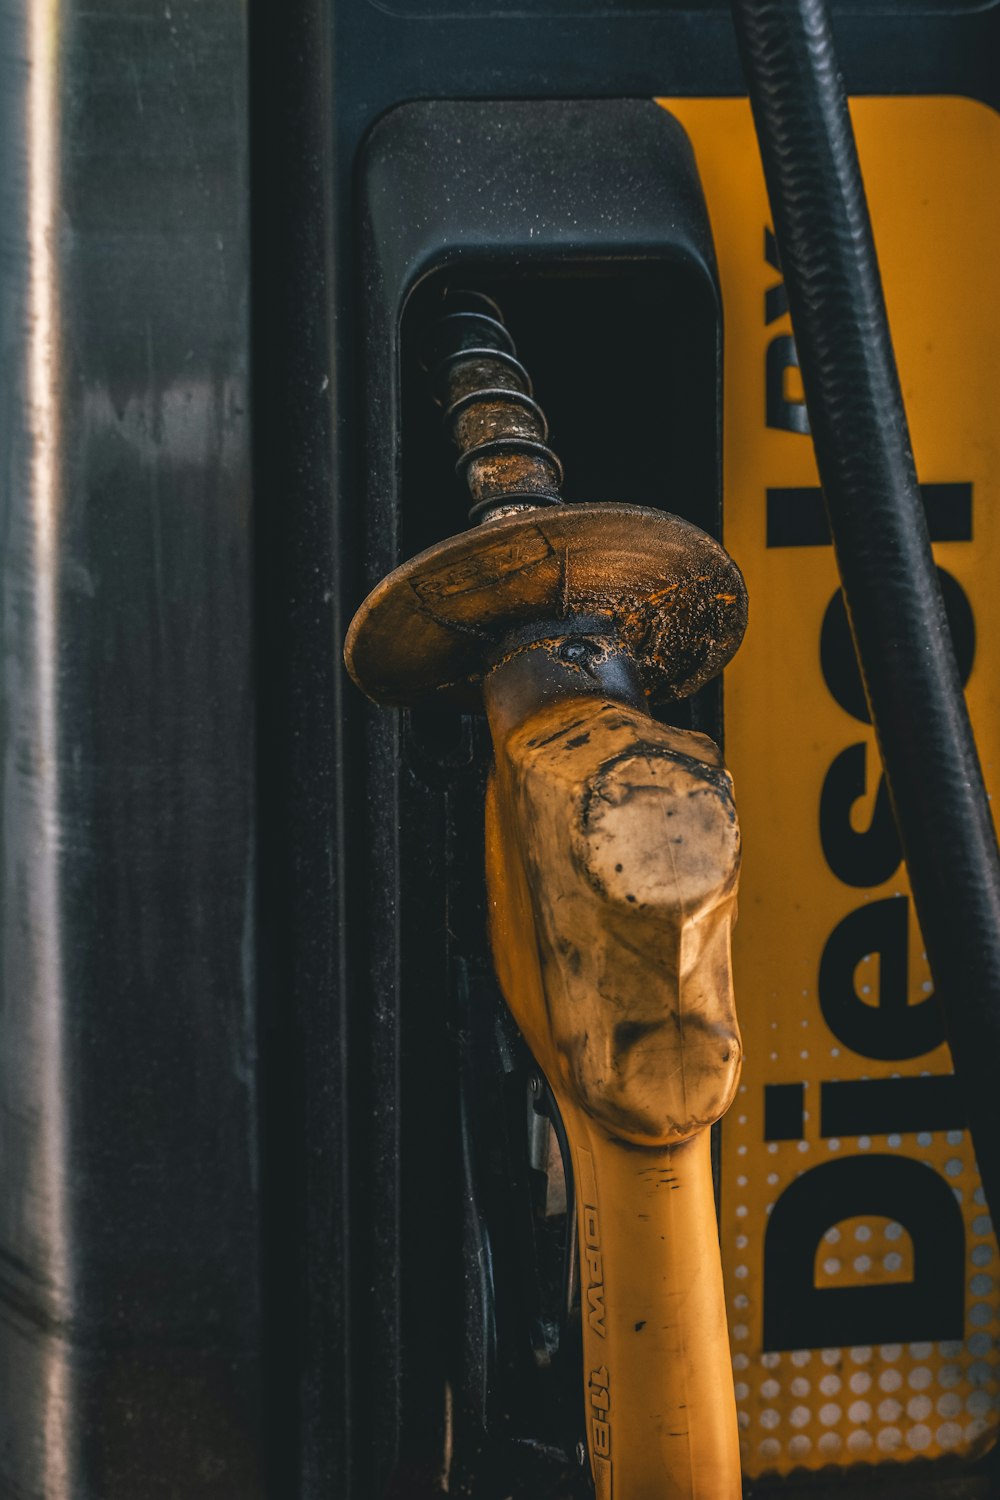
(820, 743, 903, 885)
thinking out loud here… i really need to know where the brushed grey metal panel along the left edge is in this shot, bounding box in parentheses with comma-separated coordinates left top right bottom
(0, 0, 261, 1500)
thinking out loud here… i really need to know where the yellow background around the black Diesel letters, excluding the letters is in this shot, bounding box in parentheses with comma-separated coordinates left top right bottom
(663, 98, 1000, 1478)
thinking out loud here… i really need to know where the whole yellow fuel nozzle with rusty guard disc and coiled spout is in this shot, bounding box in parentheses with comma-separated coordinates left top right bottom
(345, 289, 747, 1500)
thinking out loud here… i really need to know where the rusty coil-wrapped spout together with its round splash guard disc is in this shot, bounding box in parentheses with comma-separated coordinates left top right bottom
(345, 293, 747, 707)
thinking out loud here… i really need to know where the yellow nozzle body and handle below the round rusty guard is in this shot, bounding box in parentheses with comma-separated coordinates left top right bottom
(484, 663, 742, 1500)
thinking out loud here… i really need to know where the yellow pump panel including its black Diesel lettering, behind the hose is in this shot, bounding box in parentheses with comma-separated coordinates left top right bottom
(663, 98, 1000, 1478)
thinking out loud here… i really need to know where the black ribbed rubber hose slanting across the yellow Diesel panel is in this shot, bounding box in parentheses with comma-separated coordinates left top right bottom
(733, 0, 1000, 1217)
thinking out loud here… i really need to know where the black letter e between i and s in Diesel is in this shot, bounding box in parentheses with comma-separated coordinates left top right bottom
(819, 896, 945, 1062)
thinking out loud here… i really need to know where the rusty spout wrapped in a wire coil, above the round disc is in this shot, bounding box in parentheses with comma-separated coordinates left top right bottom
(423, 291, 564, 524)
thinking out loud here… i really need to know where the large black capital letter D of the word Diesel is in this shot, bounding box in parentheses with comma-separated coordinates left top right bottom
(763, 1155, 966, 1350)
